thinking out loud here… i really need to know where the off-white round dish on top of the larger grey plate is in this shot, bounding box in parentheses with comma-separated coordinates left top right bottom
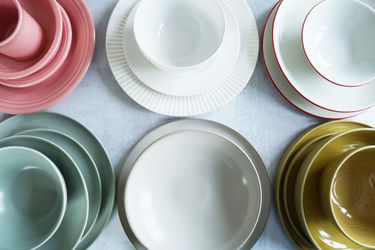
(125, 131, 261, 249)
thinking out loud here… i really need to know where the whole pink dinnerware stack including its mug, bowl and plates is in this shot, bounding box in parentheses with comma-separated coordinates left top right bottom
(0, 0, 95, 114)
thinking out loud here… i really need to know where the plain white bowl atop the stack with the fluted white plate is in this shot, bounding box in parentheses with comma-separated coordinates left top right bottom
(133, 0, 225, 73)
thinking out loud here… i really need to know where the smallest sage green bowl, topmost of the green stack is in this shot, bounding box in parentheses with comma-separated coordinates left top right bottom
(0, 147, 67, 249)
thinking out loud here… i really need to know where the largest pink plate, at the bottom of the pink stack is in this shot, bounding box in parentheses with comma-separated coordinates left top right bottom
(0, 0, 95, 114)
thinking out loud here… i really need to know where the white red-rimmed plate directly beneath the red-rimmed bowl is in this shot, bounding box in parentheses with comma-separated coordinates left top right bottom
(272, 0, 375, 113)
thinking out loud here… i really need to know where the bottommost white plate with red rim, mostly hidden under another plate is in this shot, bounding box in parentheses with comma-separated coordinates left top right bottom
(262, 5, 360, 120)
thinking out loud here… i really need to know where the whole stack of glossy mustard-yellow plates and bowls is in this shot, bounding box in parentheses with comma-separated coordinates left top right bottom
(276, 121, 375, 249)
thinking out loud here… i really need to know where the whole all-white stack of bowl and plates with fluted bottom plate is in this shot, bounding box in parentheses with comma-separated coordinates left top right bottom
(106, 0, 259, 116)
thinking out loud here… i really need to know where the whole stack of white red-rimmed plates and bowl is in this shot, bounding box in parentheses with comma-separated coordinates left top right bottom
(263, 0, 375, 119)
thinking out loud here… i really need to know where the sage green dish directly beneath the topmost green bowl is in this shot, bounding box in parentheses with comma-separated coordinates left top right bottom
(0, 135, 89, 250)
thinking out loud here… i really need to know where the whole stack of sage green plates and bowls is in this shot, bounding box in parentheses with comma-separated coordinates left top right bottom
(0, 113, 115, 250)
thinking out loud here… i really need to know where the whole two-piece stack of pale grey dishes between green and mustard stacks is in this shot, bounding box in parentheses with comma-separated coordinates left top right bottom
(117, 120, 271, 250)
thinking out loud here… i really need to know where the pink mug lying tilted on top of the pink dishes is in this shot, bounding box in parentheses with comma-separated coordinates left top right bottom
(0, 0, 44, 60)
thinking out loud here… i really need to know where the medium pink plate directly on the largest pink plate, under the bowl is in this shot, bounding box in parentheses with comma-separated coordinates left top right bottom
(0, 6, 72, 88)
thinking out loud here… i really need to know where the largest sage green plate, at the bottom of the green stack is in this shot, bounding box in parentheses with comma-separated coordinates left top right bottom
(0, 112, 116, 249)
